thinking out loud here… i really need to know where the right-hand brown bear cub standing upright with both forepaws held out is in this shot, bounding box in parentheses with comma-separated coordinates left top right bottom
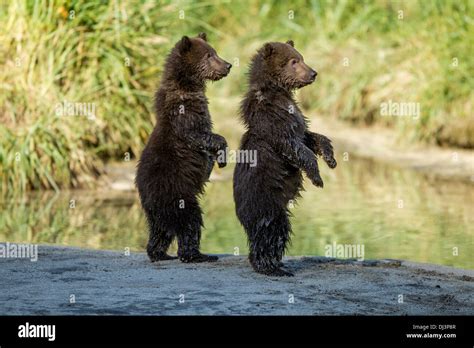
(234, 40, 337, 276)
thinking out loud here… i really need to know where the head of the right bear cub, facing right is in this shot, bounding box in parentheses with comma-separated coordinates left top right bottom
(251, 40, 318, 90)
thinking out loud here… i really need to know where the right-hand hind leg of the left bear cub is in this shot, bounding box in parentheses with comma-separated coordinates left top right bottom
(176, 203, 218, 263)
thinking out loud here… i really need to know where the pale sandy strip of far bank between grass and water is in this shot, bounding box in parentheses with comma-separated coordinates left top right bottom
(97, 117, 474, 191)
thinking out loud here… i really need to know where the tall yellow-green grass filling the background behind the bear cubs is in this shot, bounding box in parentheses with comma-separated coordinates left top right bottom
(0, 0, 474, 194)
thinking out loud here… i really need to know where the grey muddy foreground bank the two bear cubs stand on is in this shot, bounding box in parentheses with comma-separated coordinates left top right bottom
(0, 245, 474, 315)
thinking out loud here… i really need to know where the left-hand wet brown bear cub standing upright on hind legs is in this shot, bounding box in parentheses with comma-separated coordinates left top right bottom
(136, 33, 232, 262)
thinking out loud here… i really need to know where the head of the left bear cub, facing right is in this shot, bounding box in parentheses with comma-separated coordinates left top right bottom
(175, 33, 232, 81)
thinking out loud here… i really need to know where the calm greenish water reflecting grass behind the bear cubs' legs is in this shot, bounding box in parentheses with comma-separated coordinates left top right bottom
(0, 159, 474, 269)
